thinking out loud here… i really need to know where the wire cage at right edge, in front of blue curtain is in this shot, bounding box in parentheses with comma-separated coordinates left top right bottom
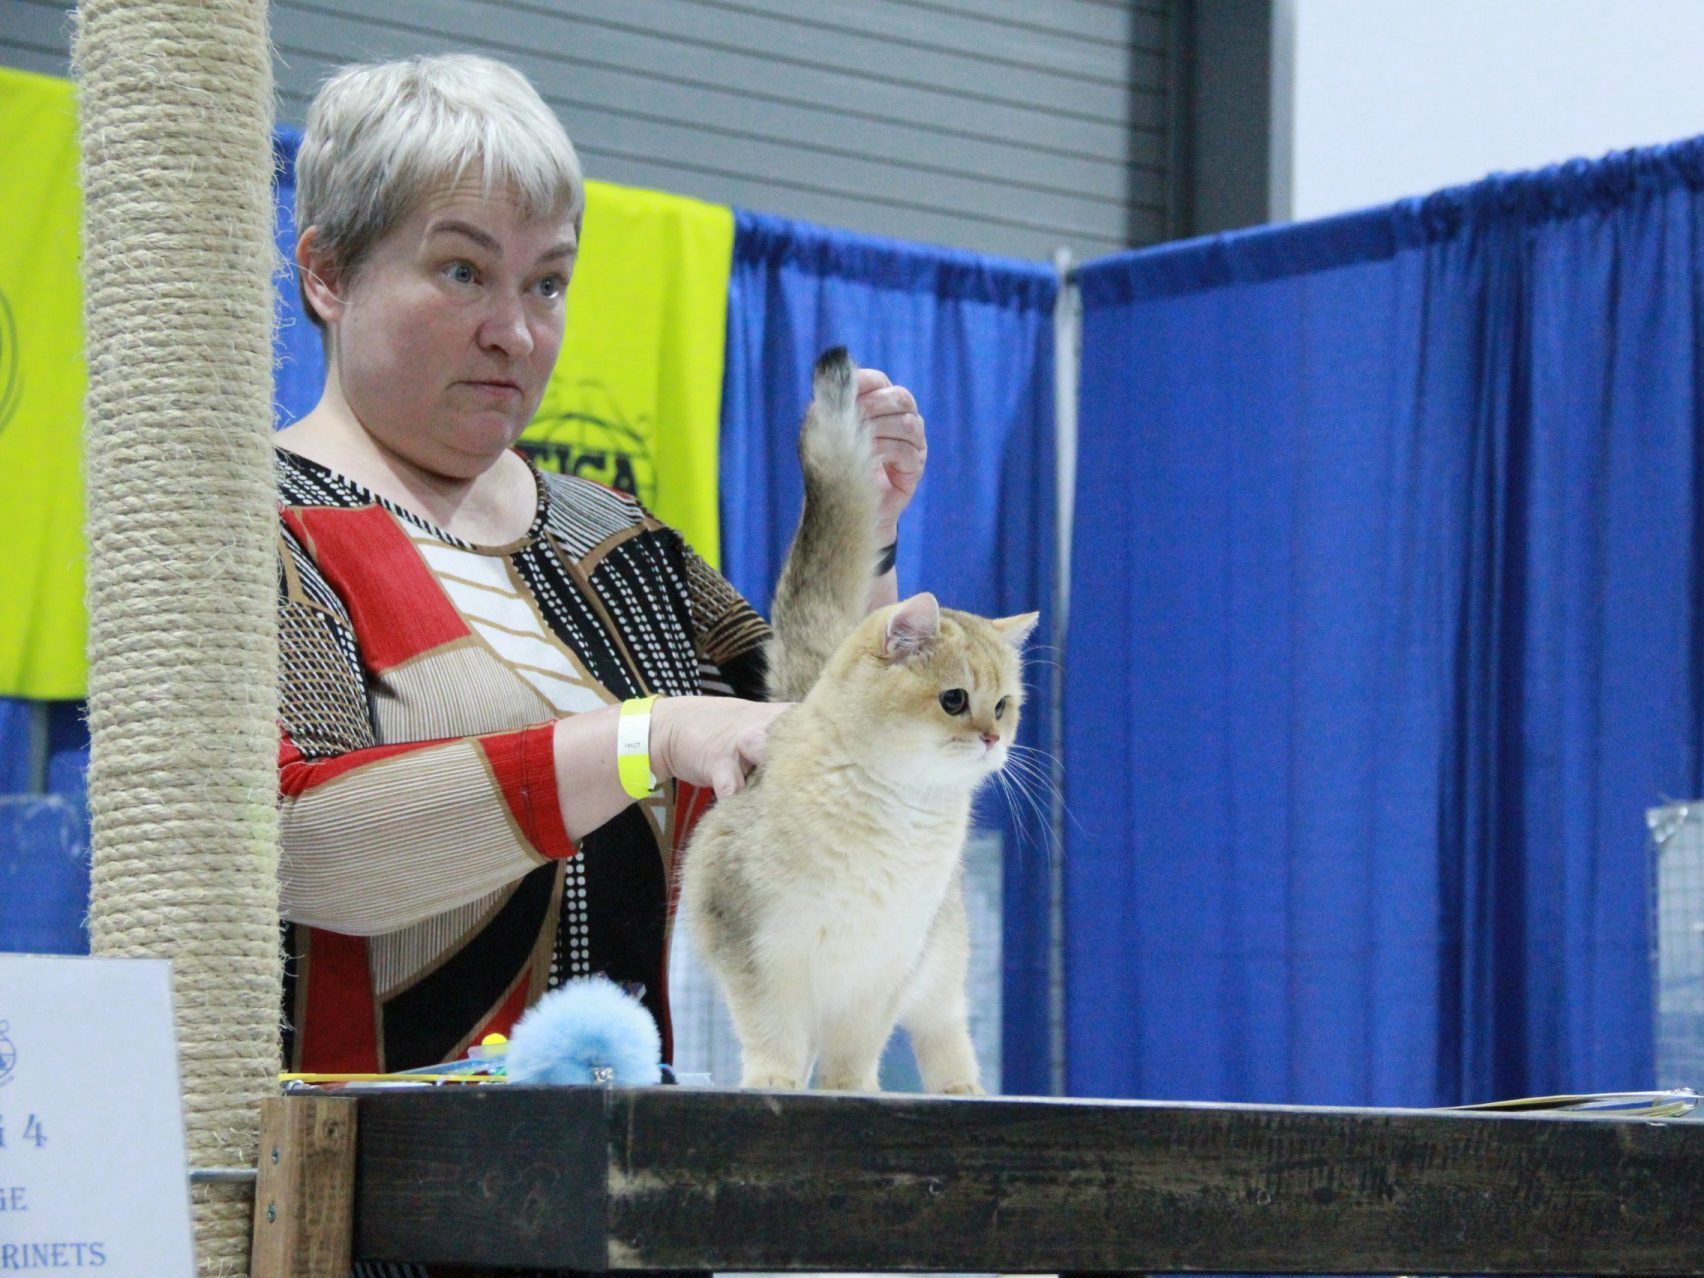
(1646, 799, 1704, 1091)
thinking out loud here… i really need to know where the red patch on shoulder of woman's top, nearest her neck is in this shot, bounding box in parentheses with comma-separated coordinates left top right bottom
(285, 506, 472, 673)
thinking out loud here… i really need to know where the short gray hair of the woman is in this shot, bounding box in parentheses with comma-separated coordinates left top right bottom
(296, 53, 586, 324)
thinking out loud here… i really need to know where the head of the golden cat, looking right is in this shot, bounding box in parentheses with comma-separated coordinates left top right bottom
(811, 595, 1038, 786)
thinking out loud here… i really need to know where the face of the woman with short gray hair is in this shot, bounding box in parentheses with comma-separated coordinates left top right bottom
(325, 174, 578, 479)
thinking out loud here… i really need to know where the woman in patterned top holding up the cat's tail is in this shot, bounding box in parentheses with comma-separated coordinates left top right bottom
(278, 56, 925, 1072)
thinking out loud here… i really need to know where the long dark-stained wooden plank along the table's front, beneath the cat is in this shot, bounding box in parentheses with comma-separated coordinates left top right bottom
(356, 1087, 1704, 1275)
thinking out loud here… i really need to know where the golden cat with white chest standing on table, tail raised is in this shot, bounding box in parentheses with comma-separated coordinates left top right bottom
(682, 349, 1036, 1094)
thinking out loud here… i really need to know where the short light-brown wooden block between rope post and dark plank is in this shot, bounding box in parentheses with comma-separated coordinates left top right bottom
(250, 1096, 356, 1278)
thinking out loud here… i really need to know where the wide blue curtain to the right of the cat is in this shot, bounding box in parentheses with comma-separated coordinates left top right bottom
(1065, 140, 1704, 1104)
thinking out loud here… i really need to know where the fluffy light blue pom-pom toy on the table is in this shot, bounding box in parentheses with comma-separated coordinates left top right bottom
(504, 976, 663, 1087)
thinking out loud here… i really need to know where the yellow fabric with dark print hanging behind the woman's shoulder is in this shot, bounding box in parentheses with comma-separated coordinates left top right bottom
(523, 182, 734, 564)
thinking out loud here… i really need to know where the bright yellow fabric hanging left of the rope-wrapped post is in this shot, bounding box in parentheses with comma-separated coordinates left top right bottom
(0, 68, 87, 699)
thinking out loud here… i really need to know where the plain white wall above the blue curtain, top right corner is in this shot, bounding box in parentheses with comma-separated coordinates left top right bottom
(1271, 0, 1704, 222)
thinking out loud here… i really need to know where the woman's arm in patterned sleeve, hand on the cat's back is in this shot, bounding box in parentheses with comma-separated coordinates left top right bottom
(279, 530, 786, 935)
